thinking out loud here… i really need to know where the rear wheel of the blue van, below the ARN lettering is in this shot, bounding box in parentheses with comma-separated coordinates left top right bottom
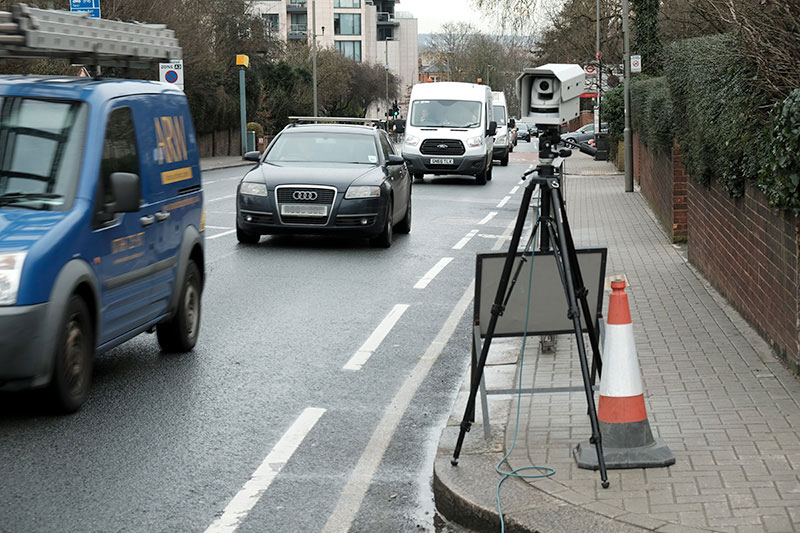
(156, 261, 202, 352)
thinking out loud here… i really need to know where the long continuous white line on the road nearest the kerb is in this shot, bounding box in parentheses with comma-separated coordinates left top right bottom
(323, 281, 475, 533)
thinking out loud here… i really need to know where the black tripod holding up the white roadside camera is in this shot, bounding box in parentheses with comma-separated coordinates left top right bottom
(450, 127, 609, 488)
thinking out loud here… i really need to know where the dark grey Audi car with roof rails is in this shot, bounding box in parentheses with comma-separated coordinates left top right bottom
(236, 117, 411, 248)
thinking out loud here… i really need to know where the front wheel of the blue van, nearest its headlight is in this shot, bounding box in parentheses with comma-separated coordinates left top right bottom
(49, 294, 94, 413)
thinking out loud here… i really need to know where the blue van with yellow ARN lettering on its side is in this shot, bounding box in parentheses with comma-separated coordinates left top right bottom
(0, 76, 205, 412)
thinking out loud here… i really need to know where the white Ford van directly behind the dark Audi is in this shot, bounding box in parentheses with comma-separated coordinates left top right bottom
(403, 82, 497, 185)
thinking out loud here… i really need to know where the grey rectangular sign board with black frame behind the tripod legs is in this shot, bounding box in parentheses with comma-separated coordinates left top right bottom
(474, 248, 608, 337)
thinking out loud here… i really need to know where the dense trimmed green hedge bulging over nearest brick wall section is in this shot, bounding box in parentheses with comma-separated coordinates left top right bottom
(665, 35, 767, 197)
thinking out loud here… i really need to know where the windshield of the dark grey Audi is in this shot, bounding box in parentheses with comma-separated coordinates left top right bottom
(264, 131, 378, 165)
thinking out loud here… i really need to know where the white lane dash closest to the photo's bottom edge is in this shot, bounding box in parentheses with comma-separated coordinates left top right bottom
(206, 407, 325, 533)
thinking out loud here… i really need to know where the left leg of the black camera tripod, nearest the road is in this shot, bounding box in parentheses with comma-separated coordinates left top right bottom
(450, 181, 537, 466)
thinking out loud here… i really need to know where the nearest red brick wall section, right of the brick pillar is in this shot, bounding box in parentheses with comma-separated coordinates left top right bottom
(688, 180, 800, 372)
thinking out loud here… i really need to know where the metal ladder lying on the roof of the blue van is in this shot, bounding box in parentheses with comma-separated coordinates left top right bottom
(0, 4, 182, 68)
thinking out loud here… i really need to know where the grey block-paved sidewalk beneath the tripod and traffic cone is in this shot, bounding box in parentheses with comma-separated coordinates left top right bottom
(434, 154, 800, 532)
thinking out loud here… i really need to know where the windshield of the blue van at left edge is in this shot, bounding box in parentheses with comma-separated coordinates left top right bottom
(0, 96, 87, 210)
